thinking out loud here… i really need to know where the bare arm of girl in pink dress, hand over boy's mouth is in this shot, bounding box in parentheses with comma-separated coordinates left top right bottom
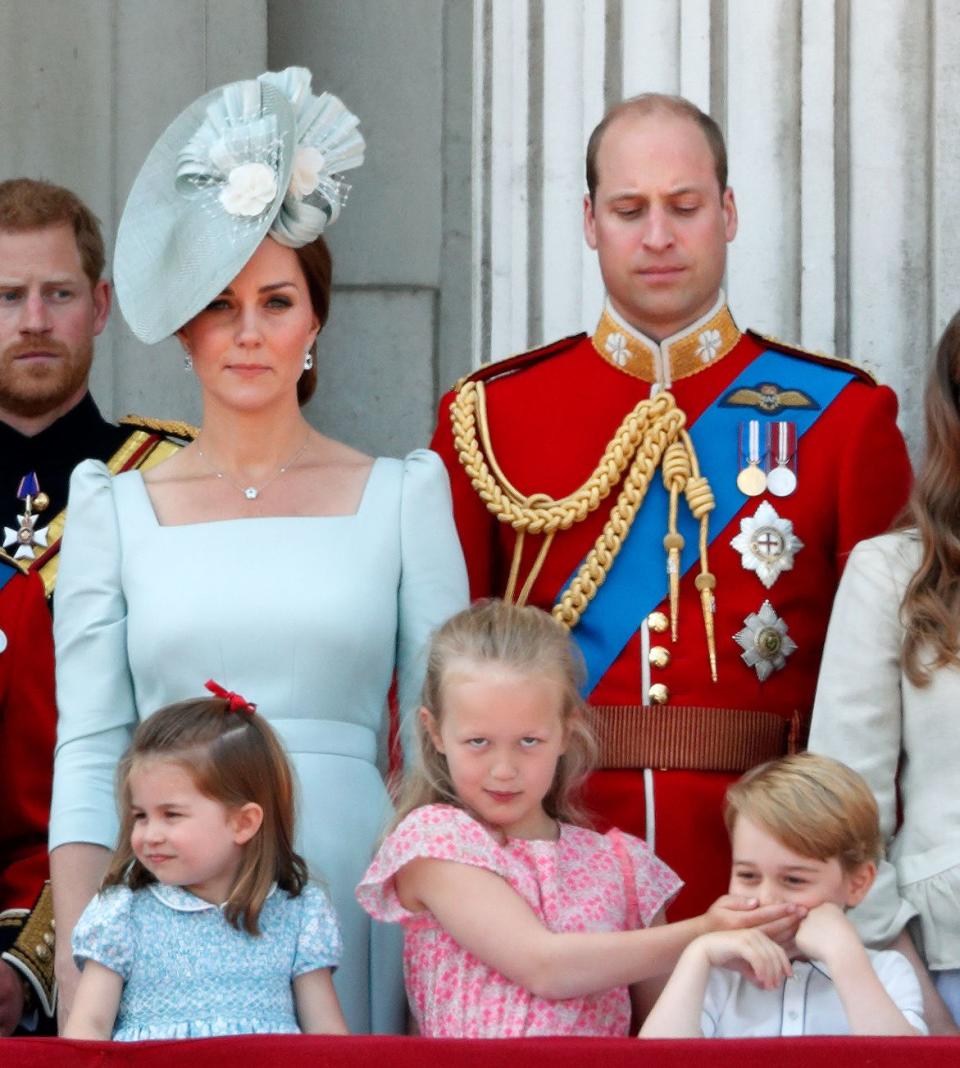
(396, 858, 798, 999)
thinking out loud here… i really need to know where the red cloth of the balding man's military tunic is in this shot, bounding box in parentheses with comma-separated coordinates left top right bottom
(432, 310, 910, 918)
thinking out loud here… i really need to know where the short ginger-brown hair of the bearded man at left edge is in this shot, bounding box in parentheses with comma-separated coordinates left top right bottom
(0, 178, 106, 286)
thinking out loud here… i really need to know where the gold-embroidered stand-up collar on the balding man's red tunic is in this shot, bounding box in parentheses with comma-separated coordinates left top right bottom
(593, 290, 740, 392)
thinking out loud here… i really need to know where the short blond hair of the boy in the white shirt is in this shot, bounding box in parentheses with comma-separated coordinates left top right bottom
(724, 753, 883, 871)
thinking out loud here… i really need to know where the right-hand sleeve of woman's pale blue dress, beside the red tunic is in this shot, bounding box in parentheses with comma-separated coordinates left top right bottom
(396, 449, 468, 755)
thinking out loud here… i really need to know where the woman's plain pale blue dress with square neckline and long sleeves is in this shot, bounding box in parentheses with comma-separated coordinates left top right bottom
(50, 450, 468, 1033)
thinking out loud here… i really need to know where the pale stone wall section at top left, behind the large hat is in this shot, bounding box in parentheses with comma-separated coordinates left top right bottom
(0, 0, 267, 420)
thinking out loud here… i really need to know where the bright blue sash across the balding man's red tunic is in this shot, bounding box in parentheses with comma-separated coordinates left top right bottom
(564, 349, 854, 696)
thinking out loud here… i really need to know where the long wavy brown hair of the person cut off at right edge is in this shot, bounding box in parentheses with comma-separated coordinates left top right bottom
(900, 312, 960, 686)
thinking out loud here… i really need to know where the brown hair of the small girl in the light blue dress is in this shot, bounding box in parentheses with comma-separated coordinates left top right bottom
(101, 697, 308, 935)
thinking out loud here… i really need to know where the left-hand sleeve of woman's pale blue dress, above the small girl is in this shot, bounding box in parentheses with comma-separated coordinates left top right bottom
(49, 460, 137, 849)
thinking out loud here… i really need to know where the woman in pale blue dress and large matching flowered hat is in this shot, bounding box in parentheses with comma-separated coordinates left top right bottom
(50, 68, 467, 1032)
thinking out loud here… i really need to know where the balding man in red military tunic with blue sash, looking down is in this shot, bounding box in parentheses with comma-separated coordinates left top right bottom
(434, 95, 910, 918)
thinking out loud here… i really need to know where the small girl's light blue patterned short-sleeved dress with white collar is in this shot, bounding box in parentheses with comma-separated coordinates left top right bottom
(73, 883, 341, 1042)
